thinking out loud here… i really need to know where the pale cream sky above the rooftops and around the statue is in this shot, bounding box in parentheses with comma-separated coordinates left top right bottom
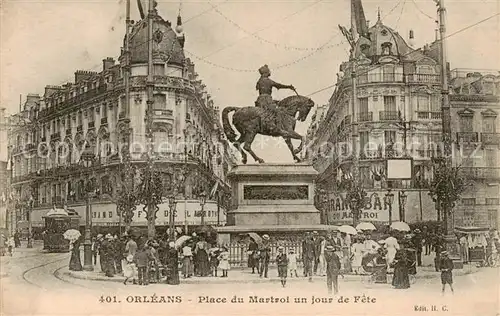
(0, 0, 500, 162)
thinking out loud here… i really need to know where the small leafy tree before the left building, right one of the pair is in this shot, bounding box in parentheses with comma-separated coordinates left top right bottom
(136, 164, 163, 239)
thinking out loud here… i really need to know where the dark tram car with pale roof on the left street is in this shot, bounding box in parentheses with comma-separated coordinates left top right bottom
(43, 208, 80, 252)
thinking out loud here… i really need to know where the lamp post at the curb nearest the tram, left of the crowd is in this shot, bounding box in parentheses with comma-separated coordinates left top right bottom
(81, 146, 95, 271)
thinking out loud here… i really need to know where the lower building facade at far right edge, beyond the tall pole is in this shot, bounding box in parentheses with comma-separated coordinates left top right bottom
(450, 69, 500, 229)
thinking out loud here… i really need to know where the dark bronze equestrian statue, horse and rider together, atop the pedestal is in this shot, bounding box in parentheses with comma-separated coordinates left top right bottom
(222, 65, 314, 164)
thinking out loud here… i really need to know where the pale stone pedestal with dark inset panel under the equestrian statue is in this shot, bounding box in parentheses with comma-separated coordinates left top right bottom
(217, 164, 335, 240)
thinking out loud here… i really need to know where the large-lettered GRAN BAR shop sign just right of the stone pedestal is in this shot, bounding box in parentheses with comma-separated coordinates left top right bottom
(328, 191, 399, 223)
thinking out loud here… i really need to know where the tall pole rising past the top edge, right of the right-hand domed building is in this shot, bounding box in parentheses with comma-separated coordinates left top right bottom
(434, 0, 459, 257)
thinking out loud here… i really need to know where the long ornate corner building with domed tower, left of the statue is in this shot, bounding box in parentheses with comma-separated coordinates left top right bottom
(9, 8, 235, 235)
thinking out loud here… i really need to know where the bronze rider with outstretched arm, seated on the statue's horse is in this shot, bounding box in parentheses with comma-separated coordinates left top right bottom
(255, 65, 295, 134)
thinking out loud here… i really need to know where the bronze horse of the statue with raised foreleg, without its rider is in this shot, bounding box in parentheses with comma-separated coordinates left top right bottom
(222, 95, 314, 164)
